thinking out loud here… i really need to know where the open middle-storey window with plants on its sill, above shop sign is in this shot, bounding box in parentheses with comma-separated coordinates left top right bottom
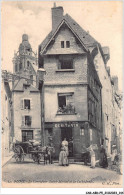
(57, 93, 75, 114)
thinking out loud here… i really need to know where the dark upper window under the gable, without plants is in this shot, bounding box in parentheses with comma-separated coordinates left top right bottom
(59, 59, 73, 69)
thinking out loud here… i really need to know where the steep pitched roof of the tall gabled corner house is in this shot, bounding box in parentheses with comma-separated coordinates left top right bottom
(39, 14, 98, 54)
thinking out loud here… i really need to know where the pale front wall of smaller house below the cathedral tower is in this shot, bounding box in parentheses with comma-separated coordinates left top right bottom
(13, 89, 41, 141)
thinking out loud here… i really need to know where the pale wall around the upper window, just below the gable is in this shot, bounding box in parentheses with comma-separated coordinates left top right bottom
(44, 55, 87, 85)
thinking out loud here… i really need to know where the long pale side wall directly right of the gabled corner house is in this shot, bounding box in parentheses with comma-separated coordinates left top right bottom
(94, 46, 114, 154)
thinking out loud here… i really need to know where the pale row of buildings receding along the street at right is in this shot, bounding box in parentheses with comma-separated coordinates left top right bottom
(94, 44, 121, 155)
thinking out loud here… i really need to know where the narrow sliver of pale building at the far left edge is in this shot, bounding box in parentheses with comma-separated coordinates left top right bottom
(1, 79, 13, 157)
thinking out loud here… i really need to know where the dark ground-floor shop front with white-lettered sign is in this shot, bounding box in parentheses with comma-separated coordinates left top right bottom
(45, 122, 90, 159)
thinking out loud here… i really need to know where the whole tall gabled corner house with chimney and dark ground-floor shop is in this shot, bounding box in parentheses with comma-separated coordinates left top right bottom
(39, 7, 102, 159)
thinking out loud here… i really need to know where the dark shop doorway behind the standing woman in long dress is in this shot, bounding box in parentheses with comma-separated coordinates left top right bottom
(61, 127, 73, 157)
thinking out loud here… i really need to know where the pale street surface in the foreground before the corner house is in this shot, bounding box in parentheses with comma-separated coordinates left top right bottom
(3, 159, 122, 185)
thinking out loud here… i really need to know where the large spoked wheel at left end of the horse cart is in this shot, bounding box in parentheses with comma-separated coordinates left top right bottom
(14, 146, 25, 162)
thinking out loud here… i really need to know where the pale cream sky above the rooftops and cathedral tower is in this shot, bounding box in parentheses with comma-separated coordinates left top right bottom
(1, 1, 123, 90)
